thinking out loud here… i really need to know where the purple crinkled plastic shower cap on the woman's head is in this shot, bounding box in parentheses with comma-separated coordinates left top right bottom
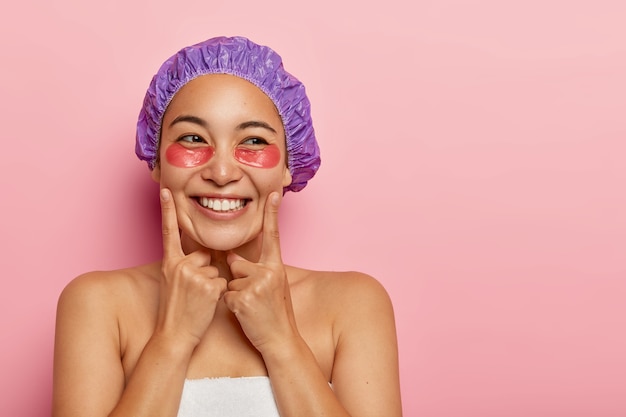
(135, 37, 320, 191)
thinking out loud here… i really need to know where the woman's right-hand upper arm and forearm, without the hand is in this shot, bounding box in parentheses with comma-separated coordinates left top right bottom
(263, 273, 402, 417)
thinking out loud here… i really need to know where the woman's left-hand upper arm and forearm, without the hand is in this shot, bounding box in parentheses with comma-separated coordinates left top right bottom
(52, 274, 193, 417)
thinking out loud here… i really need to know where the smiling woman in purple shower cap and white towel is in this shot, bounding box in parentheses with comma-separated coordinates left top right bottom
(53, 37, 401, 417)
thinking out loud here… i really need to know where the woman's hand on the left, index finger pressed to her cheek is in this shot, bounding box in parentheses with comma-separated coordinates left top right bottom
(157, 188, 226, 347)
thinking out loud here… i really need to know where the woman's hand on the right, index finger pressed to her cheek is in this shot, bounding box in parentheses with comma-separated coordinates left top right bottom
(224, 192, 297, 354)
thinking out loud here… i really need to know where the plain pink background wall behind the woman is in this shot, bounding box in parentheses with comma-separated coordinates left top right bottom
(0, 0, 626, 417)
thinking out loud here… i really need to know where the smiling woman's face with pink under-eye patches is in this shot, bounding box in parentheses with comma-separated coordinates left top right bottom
(153, 74, 291, 250)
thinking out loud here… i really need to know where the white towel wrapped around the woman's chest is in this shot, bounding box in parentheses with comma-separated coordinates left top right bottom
(178, 376, 280, 417)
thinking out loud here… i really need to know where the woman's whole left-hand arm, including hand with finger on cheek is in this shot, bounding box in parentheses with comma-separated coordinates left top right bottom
(52, 190, 226, 417)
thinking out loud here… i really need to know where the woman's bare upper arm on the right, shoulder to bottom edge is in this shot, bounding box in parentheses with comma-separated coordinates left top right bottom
(332, 274, 402, 417)
